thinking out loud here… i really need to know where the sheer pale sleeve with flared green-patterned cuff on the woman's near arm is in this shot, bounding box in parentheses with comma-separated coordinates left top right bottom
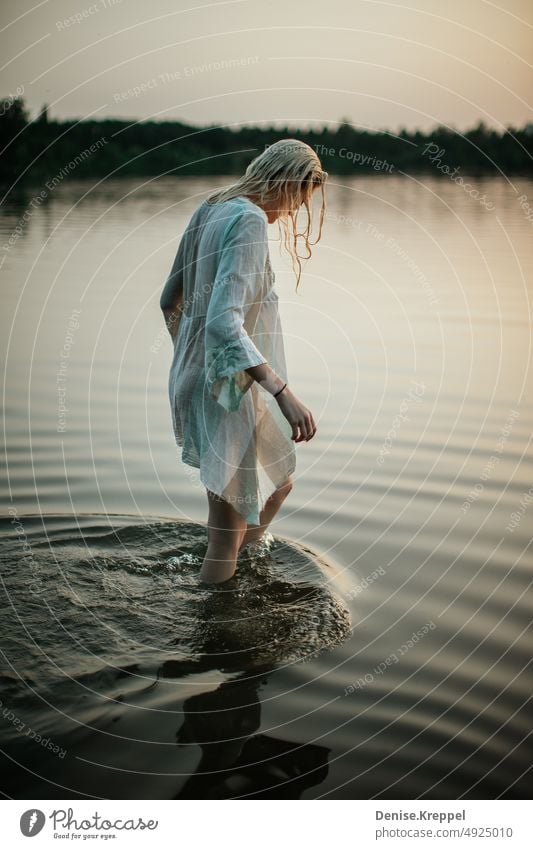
(205, 211, 268, 412)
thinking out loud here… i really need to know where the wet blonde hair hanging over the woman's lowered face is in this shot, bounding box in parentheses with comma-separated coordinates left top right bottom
(207, 139, 328, 291)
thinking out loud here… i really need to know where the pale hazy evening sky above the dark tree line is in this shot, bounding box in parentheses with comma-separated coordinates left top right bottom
(0, 0, 533, 131)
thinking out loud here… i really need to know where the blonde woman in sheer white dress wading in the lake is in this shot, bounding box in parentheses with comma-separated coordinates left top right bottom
(160, 139, 327, 583)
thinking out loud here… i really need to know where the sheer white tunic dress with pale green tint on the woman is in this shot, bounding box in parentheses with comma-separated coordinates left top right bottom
(160, 197, 296, 525)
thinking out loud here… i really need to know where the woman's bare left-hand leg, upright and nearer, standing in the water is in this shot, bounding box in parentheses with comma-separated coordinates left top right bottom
(200, 489, 246, 584)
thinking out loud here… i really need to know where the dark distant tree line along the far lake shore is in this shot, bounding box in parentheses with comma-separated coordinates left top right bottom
(0, 97, 533, 187)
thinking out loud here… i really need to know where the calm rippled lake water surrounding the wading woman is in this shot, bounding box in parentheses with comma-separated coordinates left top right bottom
(0, 176, 533, 798)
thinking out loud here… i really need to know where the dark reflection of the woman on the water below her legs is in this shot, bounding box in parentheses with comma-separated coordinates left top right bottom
(159, 568, 340, 799)
